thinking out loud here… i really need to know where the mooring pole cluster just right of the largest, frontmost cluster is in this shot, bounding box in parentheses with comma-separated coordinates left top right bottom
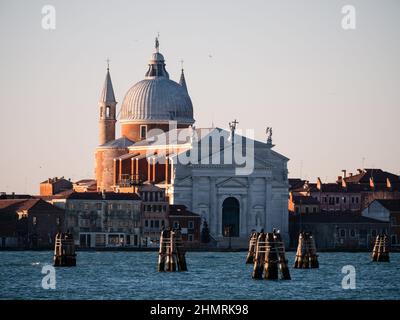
(294, 232, 319, 269)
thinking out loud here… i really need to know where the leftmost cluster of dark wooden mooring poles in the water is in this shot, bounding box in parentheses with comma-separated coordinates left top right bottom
(54, 231, 76, 267)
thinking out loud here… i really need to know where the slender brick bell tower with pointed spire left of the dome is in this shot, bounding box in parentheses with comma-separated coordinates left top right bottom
(99, 60, 117, 145)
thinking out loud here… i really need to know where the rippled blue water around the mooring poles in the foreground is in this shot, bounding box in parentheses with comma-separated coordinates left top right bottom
(0, 251, 400, 299)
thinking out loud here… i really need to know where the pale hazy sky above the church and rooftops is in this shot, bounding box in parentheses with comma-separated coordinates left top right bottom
(0, 0, 400, 194)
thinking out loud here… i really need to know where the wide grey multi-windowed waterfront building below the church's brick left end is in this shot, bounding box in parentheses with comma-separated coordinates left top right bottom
(49, 192, 141, 248)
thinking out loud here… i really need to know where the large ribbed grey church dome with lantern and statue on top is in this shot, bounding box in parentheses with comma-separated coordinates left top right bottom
(120, 42, 194, 125)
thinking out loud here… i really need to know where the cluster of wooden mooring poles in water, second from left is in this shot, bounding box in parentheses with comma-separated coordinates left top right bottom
(158, 228, 187, 272)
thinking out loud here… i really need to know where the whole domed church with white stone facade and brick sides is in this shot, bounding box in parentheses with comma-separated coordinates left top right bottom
(95, 40, 289, 246)
